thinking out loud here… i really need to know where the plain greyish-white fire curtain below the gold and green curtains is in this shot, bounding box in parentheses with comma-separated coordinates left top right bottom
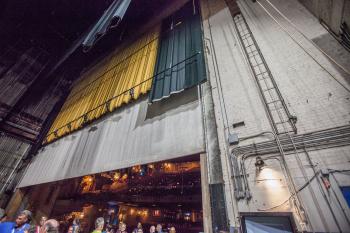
(18, 96, 204, 187)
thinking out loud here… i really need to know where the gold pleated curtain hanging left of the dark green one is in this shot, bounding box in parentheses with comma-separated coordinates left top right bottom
(46, 26, 160, 142)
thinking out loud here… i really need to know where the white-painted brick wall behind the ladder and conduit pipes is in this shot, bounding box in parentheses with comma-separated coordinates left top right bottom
(201, 0, 350, 232)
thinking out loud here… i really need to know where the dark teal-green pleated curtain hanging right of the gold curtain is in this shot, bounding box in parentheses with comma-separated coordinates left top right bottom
(150, 1, 206, 102)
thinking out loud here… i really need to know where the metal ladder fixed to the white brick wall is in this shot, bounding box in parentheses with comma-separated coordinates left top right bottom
(233, 14, 297, 134)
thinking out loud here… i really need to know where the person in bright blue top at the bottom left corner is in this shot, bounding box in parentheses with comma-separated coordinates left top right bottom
(0, 210, 32, 233)
